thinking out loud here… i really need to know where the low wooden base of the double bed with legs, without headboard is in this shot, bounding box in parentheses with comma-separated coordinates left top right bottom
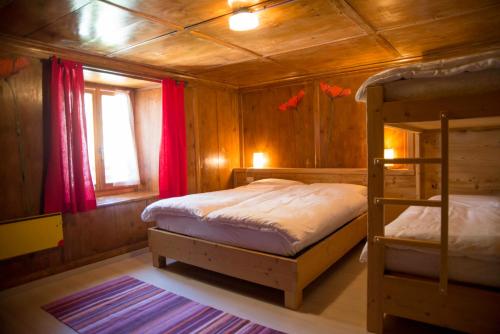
(149, 214, 366, 309)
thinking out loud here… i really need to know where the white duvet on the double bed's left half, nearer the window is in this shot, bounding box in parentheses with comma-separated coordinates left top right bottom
(141, 179, 302, 221)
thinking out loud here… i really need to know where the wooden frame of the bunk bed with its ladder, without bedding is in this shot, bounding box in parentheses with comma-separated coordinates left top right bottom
(367, 77, 500, 333)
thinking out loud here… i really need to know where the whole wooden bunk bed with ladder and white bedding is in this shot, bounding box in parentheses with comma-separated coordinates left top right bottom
(357, 51, 500, 333)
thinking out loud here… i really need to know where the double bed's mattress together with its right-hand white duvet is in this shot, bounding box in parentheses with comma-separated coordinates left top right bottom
(152, 184, 367, 256)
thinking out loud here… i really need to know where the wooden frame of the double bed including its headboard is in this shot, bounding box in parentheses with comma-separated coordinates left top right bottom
(148, 168, 367, 309)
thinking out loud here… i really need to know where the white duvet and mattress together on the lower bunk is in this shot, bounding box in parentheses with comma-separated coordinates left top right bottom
(360, 195, 500, 287)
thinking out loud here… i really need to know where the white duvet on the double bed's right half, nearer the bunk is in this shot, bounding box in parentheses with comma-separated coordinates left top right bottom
(205, 183, 367, 251)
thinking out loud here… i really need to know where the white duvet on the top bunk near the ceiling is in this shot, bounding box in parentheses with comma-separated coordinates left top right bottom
(356, 51, 500, 102)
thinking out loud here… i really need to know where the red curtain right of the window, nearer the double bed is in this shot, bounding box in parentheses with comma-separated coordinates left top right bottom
(159, 79, 187, 198)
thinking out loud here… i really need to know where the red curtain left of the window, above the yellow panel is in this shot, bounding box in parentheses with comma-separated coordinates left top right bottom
(44, 57, 96, 213)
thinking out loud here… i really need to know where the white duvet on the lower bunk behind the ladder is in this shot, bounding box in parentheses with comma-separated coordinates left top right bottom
(360, 195, 500, 263)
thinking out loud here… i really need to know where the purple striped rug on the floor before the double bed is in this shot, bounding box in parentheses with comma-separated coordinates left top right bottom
(42, 276, 282, 334)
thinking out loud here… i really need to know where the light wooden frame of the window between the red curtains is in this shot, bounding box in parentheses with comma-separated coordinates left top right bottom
(85, 82, 140, 196)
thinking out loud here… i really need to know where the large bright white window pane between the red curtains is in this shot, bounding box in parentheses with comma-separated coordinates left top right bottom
(101, 93, 139, 184)
